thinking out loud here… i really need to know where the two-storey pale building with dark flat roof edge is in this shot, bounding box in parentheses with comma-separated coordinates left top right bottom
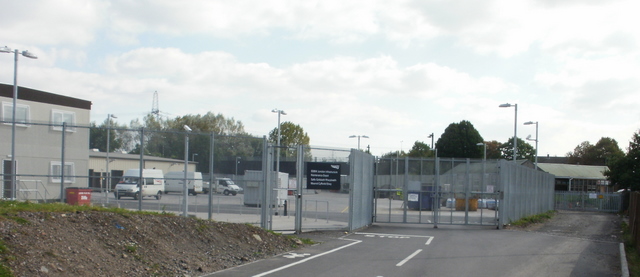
(0, 84, 91, 200)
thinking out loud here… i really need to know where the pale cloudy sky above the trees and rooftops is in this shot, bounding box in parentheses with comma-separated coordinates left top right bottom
(0, 0, 640, 156)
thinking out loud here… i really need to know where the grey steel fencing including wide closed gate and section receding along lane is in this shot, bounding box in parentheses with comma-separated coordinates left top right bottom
(374, 158, 554, 227)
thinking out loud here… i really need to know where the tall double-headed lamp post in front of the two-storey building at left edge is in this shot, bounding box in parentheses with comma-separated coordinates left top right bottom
(0, 46, 37, 200)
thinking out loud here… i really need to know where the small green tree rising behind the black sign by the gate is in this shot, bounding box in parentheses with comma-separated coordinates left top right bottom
(269, 121, 311, 157)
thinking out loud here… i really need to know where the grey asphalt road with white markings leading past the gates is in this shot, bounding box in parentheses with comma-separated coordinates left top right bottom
(210, 215, 621, 277)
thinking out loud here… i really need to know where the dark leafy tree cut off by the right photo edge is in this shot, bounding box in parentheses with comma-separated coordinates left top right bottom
(604, 130, 640, 191)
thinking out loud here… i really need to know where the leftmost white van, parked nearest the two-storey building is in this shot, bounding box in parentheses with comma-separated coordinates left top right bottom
(113, 168, 164, 200)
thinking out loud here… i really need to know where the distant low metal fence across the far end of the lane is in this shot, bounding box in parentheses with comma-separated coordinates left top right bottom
(554, 191, 622, 213)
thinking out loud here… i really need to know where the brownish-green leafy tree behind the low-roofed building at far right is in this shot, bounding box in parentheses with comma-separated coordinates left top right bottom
(567, 137, 624, 165)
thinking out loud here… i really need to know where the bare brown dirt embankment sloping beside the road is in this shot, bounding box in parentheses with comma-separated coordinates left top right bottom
(0, 212, 300, 276)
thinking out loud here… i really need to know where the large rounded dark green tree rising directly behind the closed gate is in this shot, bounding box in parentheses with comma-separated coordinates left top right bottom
(436, 120, 484, 158)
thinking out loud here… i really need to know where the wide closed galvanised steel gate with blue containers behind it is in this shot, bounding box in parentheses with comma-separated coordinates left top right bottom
(374, 158, 501, 227)
